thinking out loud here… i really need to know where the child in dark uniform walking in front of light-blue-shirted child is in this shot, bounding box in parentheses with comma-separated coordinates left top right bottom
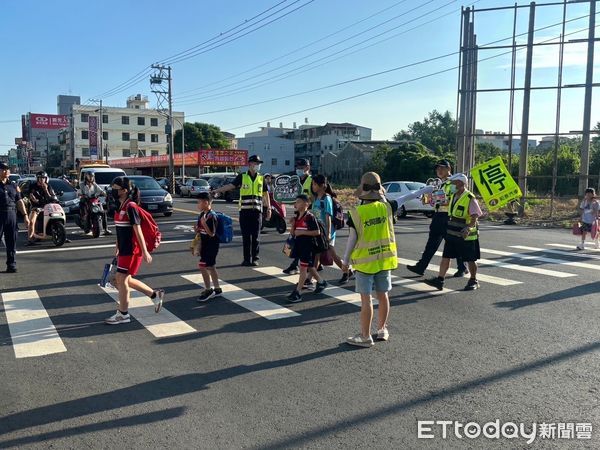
(288, 194, 327, 303)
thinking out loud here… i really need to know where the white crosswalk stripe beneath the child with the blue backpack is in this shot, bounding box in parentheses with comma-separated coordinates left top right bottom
(182, 274, 300, 320)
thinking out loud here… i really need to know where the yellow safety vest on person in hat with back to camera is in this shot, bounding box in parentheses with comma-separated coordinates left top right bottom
(350, 201, 398, 274)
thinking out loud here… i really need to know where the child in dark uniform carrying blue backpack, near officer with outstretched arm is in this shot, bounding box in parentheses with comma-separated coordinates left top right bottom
(196, 192, 223, 303)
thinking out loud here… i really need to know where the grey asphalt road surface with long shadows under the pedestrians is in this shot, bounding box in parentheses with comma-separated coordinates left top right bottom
(0, 199, 600, 449)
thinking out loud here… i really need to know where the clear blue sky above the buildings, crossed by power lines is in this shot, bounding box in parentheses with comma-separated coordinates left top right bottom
(0, 0, 600, 153)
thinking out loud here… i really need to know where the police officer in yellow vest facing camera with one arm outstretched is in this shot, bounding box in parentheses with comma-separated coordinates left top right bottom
(212, 155, 271, 266)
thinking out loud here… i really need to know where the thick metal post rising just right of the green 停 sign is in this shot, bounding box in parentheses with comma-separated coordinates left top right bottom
(519, 2, 535, 214)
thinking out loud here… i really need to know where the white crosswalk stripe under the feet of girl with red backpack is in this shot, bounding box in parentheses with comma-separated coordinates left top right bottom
(100, 287, 196, 338)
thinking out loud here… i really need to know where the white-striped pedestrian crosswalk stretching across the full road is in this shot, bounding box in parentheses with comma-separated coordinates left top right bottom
(0, 243, 600, 358)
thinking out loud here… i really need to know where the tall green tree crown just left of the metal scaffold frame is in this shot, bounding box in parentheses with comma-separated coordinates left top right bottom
(394, 109, 457, 156)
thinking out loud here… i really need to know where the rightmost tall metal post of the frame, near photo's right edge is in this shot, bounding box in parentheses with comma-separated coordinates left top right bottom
(579, 0, 596, 197)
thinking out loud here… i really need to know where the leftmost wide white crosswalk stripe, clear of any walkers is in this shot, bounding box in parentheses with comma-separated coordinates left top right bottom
(1, 291, 67, 358)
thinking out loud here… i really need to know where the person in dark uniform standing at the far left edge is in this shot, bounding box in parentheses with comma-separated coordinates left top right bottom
(0, 163, 29, 273)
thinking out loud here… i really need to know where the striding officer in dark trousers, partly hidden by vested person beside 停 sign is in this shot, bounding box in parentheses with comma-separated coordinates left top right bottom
(407, 160, 468, 277)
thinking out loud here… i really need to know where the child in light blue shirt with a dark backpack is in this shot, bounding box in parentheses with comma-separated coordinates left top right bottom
(312, 174, 354, 284)
